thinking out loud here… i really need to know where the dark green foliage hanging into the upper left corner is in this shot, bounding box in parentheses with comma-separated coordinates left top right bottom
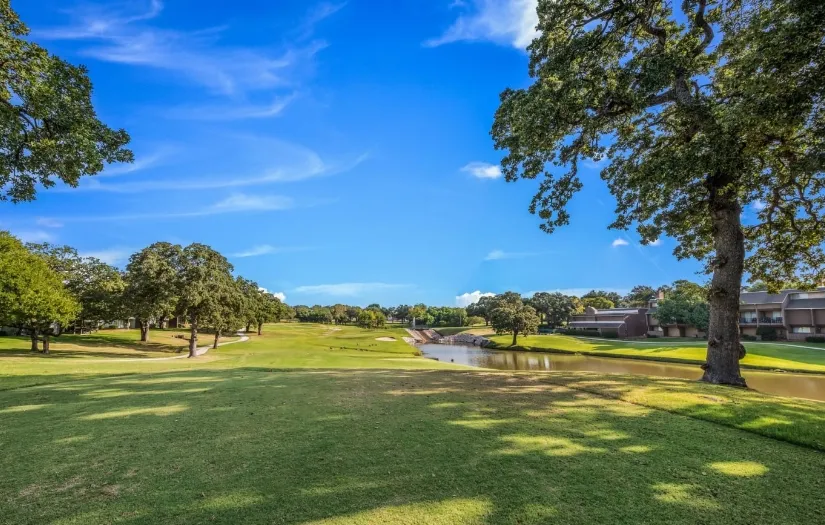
(0, 0, 133, 202)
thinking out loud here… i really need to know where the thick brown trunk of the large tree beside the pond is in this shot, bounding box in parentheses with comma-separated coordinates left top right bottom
(702, 174, 747, 386)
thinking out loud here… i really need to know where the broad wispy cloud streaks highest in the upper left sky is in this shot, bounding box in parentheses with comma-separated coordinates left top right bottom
(34, 0, 326, 95)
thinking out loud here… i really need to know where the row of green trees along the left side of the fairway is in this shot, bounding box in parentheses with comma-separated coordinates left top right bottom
(0, 232, 291, 357)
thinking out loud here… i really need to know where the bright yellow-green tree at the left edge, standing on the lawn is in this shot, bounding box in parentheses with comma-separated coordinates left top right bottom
(0, 232, 80, 354)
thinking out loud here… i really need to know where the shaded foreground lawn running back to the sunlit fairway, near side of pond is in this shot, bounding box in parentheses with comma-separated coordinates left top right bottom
(0, 324, 825, 525)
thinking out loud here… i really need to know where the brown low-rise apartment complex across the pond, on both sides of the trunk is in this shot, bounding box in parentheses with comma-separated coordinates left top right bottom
(569, 288, 825, 341)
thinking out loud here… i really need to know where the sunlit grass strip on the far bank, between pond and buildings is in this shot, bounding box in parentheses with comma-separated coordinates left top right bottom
(476, 330, 825, 372)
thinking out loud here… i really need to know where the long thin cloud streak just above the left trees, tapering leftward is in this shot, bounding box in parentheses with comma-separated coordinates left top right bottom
(44, 193, 295, 222)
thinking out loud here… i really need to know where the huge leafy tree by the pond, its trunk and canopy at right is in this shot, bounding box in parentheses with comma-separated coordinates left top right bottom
(492, 0, 825, 385)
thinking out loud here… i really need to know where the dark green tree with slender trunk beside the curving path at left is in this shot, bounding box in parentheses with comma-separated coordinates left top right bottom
(177, 243, 235, 357)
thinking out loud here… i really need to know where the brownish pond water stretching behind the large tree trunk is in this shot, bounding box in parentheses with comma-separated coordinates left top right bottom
(418, 344, 825, 401)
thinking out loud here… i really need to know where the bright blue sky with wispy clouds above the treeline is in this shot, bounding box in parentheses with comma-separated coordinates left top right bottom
(0, 0, 716, 305)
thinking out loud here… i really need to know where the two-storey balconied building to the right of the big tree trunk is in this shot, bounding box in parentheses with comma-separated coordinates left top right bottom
(739, 288, 825, 341)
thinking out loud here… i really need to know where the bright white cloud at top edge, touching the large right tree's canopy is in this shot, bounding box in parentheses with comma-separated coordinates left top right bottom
(424, 0, 538, 49)
